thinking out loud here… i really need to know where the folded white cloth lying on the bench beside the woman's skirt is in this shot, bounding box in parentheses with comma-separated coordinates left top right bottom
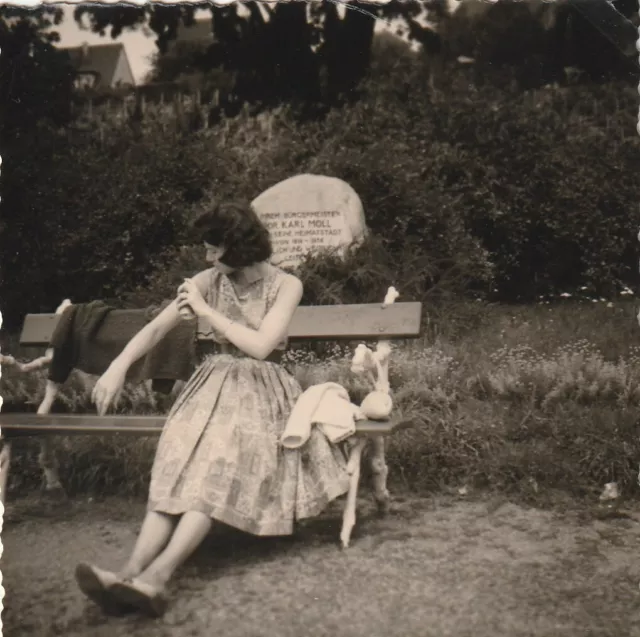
(280, 383, 365, 449)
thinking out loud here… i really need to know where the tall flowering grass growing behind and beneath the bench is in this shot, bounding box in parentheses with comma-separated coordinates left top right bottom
(0, 300, 640, 500)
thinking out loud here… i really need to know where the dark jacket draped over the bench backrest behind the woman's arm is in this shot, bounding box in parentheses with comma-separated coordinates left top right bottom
(49, 301, 197, 392)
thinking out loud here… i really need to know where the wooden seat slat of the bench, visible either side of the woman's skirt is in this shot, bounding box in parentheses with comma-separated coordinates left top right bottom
(0, 413, 408, 438)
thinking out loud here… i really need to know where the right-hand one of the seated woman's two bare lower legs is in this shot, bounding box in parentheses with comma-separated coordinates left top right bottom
(139, 511, 212, 587)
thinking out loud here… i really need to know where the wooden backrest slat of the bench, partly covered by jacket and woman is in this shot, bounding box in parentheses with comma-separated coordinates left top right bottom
(20, 303, 422, 346)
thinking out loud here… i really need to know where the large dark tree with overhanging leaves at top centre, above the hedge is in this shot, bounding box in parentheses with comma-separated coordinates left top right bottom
(76, 0, 400, 104)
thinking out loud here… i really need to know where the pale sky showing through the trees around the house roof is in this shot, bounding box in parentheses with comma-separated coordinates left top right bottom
(55, 0, 458, 84)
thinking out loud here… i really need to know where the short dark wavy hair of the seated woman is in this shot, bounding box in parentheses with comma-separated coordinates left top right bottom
(193, 202, 273, 268)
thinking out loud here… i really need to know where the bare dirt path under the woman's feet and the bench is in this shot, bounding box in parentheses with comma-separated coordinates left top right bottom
(0, 497, 640, 637)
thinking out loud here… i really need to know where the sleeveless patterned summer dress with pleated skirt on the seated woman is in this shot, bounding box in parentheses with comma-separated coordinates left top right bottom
(148, 263, 349, 535)
